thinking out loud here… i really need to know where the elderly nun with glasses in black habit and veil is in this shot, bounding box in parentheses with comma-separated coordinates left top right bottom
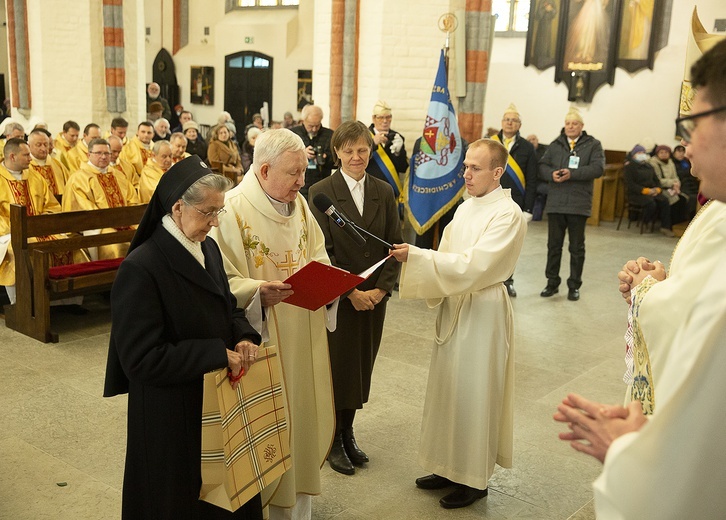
(104, 156, 262, 520)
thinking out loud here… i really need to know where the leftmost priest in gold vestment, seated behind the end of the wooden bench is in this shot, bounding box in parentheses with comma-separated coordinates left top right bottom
(0, 139, 72, 296)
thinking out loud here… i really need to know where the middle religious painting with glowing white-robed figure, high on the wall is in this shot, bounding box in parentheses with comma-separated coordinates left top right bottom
(555, 0, 621, 103)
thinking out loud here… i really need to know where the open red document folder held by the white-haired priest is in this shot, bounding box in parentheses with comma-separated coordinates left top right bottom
(283, 255, 390, 311)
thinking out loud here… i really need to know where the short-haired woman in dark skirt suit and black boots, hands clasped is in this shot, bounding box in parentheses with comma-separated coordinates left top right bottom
(309, 121, 402, 475)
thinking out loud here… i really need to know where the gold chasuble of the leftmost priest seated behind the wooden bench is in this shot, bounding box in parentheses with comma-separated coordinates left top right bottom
(0, 165, 73, 285)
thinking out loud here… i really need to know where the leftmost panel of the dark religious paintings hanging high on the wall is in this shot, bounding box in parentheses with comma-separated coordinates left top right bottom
(524, 0, 561, 70)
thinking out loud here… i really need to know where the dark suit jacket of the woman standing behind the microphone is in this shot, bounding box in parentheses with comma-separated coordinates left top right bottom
(310, 171, 403, 296)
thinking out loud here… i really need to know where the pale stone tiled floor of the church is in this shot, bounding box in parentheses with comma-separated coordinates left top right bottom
(0, 217, 676, 520)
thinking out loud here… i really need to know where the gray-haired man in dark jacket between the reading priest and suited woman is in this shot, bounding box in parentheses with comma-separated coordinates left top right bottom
(290, 105, 333, 199)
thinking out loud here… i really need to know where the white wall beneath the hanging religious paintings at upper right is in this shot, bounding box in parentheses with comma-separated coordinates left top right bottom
(484, 0, 726, 150)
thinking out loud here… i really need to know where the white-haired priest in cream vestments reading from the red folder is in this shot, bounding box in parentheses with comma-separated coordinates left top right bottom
(210, 129, 334, 520)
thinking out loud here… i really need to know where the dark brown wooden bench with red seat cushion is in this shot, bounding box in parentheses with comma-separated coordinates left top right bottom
(5, 204, 146, 343)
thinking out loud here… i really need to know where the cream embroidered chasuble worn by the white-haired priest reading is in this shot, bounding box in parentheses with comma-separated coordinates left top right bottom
(210, 174, 335, 507)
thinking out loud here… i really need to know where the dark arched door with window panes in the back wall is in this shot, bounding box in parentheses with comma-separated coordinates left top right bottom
(224, 51, 272, 131)
